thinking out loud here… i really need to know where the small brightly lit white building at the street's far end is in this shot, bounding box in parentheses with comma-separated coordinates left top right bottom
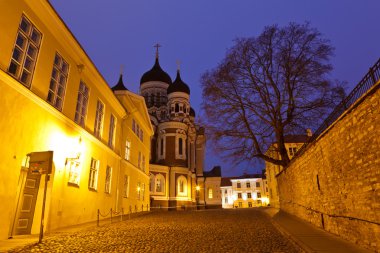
(220, 174, 269, 208)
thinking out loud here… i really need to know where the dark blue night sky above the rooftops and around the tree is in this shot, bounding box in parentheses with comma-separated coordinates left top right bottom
(50, 0, 380, 176)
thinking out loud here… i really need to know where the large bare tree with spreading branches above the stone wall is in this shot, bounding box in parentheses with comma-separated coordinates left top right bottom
(202, 23, 344, 166)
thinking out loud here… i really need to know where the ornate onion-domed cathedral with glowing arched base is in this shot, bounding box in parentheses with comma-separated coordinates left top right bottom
(140, 51, 220, 210)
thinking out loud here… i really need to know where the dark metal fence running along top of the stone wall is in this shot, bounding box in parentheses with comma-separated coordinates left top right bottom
(296, 58, 380, 156)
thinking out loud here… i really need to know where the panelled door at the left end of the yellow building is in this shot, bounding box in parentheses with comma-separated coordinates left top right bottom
(15, 172, 41, 235)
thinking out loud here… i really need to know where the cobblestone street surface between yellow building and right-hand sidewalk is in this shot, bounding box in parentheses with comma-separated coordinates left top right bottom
(8, 209, 300, 253)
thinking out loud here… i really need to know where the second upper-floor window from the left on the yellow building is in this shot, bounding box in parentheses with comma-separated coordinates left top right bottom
(47, 53, 69, 111)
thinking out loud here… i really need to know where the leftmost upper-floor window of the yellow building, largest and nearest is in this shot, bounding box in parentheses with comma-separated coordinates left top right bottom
(8, 16, 42, 88)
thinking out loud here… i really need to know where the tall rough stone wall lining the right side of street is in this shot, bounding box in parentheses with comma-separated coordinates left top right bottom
(277, 83, 380, 252)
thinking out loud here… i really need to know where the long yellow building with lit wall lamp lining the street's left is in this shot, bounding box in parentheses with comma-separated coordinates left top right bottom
(0, 0, 153, 239)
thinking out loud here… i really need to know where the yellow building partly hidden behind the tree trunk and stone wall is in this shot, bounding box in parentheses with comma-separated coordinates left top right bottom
(265, 132, 312, 208)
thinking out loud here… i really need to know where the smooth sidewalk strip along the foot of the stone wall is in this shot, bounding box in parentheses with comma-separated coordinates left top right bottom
(263, 207, 373, 253)
